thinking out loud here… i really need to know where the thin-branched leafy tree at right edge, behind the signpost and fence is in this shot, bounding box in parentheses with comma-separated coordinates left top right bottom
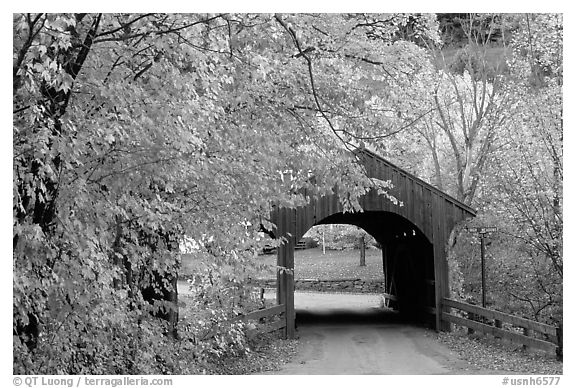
(444, 14, 563, 324)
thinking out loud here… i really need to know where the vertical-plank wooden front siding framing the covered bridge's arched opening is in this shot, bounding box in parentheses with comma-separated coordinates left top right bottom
(272, 150, 471, 338)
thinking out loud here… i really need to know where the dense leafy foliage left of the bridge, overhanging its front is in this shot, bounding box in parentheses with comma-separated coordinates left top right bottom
(13, 14, 438, 374)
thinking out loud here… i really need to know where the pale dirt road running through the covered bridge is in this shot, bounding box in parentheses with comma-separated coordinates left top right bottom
(273, 292, 482, 375)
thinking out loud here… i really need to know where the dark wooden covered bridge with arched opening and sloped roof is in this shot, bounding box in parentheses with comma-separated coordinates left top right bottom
(271, 149, 476, 338)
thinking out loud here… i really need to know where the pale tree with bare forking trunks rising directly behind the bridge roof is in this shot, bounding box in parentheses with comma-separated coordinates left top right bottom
(374, 14, 513, 204)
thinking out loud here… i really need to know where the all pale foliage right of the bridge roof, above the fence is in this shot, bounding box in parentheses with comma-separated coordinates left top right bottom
(368, 14, 563, 323)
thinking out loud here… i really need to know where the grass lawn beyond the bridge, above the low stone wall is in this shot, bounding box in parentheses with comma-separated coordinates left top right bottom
(258, 248, 383, 280)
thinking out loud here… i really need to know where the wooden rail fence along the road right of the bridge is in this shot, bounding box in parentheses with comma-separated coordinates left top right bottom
(442, 298, 563, 360)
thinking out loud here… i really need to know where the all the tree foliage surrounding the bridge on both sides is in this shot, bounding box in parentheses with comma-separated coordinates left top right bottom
(12, 14, 563, 374)
